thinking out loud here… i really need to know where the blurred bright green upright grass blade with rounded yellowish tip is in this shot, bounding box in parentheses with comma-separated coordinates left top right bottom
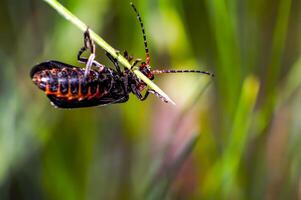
(222, 76, 260, 195)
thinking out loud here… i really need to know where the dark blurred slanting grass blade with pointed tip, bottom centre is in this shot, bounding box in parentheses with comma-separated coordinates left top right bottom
(145, 134, 200, 199)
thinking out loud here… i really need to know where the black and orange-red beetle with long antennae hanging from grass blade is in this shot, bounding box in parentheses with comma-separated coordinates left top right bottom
(30, 3, 213, 108)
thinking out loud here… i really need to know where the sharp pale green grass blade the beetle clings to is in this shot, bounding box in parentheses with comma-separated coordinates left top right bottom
(43, 0, 176, 105)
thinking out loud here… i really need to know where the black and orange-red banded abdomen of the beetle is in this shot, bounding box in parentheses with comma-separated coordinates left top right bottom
(32, 67, 106, 101)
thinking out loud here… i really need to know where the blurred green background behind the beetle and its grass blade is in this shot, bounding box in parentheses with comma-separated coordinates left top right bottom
(0, 0, 301, 200)
